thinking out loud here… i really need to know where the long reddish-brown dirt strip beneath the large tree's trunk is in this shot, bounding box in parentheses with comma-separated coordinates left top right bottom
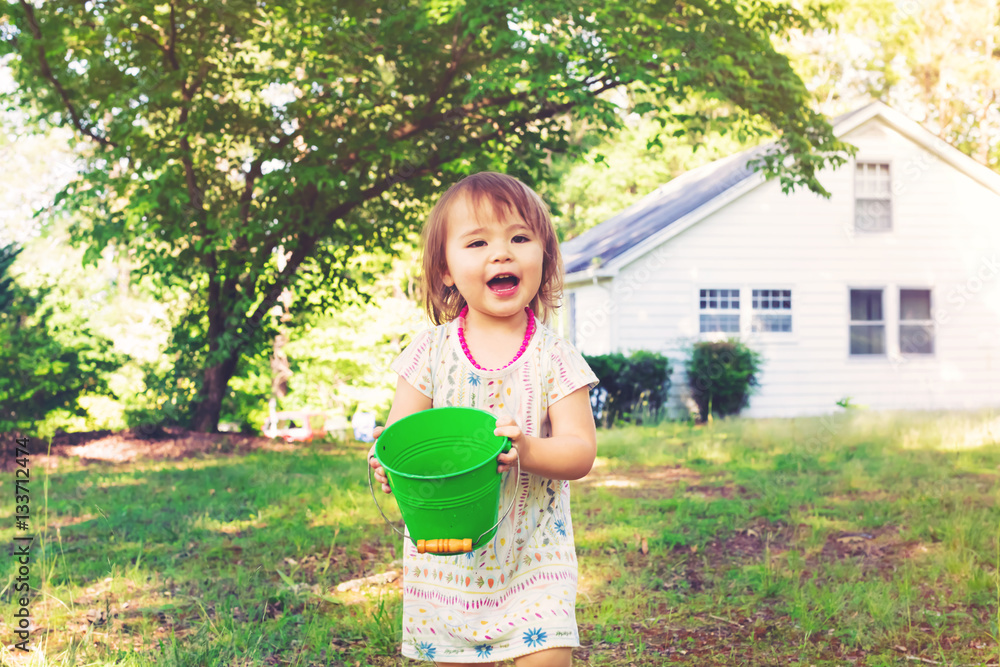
(2, 426, 302, 469)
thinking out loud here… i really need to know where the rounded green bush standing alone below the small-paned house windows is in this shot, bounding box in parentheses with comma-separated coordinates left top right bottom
(686, 338, 761, 421)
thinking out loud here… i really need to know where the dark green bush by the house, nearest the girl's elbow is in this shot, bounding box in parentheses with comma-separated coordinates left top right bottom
(584, 350, 671, 427)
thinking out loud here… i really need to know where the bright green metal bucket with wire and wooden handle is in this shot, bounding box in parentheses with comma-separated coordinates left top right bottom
(369, 407, 520, 554)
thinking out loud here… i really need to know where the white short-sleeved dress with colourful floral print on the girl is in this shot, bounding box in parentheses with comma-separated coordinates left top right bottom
(390, 320, 597, 663)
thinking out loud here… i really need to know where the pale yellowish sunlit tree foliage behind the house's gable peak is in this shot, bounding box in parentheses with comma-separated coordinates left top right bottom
(779, 0, 1000, 171)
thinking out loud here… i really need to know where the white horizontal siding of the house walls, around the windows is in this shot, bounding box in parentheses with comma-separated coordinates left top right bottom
(577, 118, 1000, 417)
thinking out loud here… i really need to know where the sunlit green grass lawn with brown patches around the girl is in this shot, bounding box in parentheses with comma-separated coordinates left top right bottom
(0, 410, 1000, 667)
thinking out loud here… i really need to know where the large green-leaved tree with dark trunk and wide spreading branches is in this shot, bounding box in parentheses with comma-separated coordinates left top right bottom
(0, 0, 844, 430)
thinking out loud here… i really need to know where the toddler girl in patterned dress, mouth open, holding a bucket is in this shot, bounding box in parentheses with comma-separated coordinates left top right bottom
(369, 172, 597, 667)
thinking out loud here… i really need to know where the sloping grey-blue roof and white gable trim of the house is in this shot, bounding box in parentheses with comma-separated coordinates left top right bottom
(561, 102, 1000, 283)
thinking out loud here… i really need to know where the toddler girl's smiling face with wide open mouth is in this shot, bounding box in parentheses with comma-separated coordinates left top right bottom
(444, 196, 545, 319)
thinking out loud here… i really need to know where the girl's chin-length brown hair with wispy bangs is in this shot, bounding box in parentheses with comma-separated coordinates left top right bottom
(422, 171, 563, 324)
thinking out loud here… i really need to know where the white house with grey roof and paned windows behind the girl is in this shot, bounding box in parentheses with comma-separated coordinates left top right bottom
(561, 102, 1000, 417)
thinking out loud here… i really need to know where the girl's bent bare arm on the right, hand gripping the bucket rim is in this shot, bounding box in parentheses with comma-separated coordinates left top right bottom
(494, 387, 597, 480)
